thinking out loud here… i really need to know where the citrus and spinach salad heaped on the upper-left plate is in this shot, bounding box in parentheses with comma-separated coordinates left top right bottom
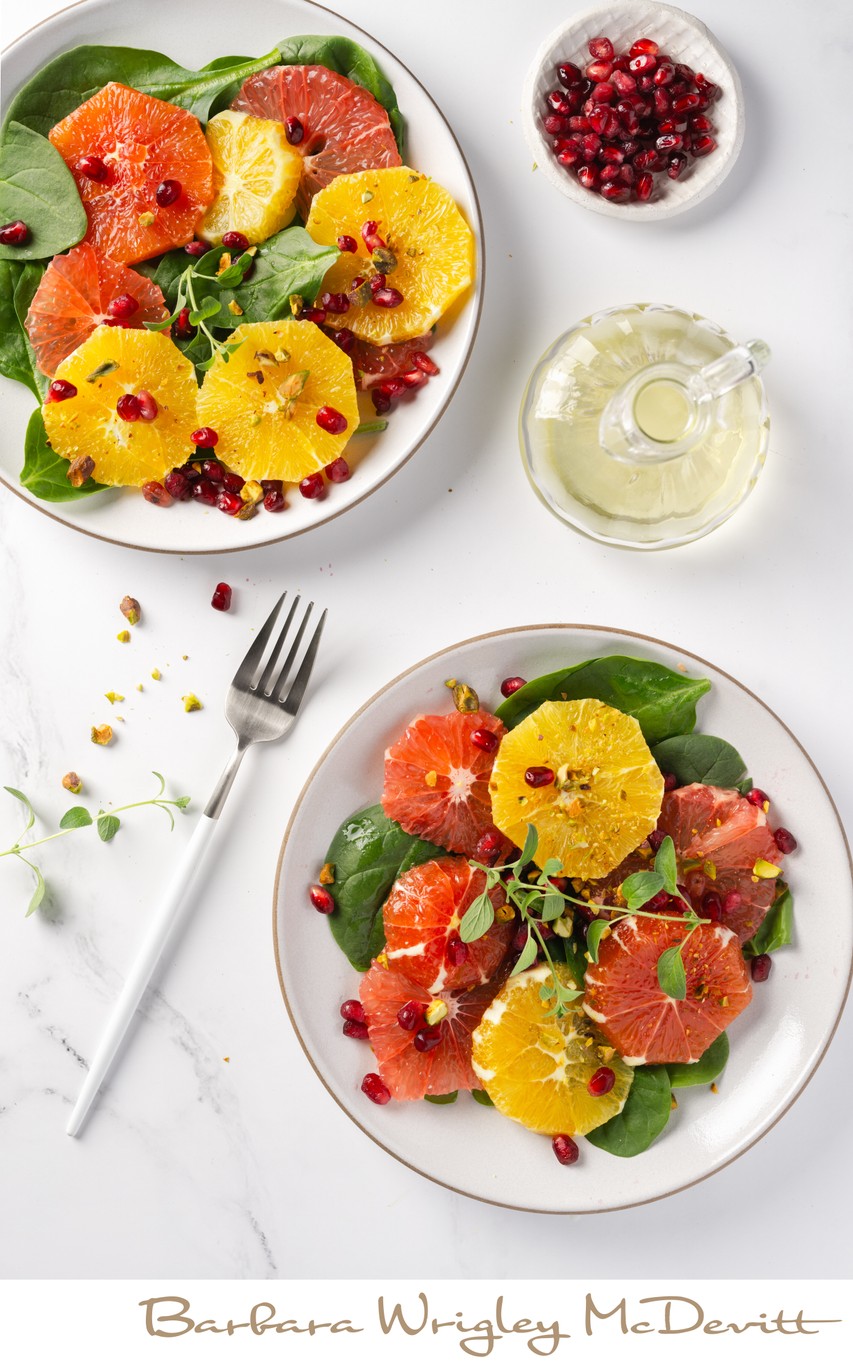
(0, 36, 474, 520)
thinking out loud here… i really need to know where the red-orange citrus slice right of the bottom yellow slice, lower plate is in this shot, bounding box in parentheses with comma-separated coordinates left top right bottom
(584, 915, 752, 1067)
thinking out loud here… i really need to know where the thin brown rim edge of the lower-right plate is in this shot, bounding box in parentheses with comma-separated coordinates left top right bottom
(272, 622, 853, 1218)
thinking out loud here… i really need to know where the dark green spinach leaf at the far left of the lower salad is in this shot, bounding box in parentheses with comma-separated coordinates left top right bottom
(325, 806, 446, 973)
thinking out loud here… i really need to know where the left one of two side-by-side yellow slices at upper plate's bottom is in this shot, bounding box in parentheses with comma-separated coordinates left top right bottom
(42, 326, 198, 485)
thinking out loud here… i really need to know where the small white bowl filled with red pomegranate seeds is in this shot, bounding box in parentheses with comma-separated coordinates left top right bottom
(522, 3, 744, 219)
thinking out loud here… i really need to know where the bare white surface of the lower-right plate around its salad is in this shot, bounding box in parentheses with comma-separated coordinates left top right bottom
(273, 626, 853, 1213)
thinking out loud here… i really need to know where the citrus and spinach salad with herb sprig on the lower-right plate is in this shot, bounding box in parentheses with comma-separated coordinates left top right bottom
(309, 656, 797, 1165)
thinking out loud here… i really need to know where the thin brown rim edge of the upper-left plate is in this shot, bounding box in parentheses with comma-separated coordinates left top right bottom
(0, 0, 487, 556)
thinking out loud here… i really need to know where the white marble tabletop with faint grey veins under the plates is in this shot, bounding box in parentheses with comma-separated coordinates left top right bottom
(0, 0, 853, 1277)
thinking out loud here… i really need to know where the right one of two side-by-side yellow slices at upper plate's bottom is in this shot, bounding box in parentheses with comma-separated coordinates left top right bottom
(198, 320, 358, 482)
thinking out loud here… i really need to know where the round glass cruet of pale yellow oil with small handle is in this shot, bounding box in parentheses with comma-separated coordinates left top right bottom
(519, 303, 770, 549)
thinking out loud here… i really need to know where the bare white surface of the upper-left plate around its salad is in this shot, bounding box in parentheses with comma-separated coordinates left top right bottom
(0, 0, 484, 555)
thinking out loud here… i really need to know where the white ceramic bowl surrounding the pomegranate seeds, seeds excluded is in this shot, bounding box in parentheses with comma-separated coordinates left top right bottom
(521, 3, 745, 223)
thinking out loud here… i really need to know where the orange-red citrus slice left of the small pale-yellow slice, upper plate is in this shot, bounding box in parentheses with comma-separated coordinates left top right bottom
(49, 81, 213, 264)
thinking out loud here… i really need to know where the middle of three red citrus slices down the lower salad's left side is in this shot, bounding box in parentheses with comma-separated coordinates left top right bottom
(383, 858, 514, 992)
